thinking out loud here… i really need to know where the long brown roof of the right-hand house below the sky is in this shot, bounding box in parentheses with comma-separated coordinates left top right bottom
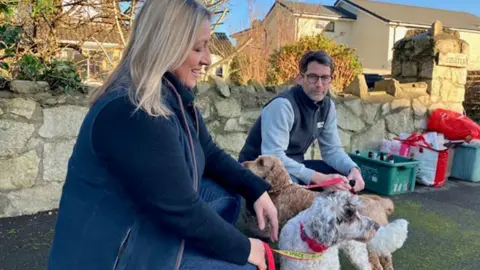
(335, 0, 480, 31)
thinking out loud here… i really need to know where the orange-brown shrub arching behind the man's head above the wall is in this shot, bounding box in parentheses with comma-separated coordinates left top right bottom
(267, 34, 362, 91)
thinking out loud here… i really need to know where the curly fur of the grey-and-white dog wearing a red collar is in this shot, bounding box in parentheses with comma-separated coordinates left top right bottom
(279, 191, 380, 270)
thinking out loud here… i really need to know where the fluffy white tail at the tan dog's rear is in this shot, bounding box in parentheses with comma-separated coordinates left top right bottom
(367, 219, 408, 256)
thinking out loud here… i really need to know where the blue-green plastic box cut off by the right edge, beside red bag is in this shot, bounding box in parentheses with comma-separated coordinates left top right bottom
(450, 143, 480, 182)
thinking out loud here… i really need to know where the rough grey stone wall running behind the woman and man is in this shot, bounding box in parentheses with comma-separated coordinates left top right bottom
(0, 80, 431, 217)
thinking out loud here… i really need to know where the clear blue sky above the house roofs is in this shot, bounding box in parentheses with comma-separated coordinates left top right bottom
(217, 0, 480, 35)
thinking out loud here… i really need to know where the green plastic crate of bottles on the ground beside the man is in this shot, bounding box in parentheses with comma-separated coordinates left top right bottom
(348, 151, 419, 196)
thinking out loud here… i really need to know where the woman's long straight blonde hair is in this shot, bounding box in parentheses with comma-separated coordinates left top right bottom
(92, 0, 211, 116)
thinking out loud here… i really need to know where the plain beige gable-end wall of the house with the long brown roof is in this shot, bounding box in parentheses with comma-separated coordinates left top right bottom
(339, 3, 390, 73)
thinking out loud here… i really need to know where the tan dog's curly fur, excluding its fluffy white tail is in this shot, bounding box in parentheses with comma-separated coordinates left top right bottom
(242, 155, 403, 270)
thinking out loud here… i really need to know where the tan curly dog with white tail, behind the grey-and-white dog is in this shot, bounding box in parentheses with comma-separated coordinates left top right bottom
(242, 155, 408, 270)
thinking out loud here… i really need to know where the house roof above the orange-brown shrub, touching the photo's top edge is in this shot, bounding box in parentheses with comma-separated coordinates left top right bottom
(275, 0, 357, 19)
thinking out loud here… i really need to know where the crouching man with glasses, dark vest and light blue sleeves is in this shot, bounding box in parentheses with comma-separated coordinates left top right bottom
(239, 51, 365, 191)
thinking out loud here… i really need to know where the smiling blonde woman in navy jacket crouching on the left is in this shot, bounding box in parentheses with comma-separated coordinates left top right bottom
(48, 0, 278, 270)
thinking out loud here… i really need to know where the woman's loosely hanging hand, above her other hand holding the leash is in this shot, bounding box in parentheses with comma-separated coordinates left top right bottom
(253, 192, 278, 241)
